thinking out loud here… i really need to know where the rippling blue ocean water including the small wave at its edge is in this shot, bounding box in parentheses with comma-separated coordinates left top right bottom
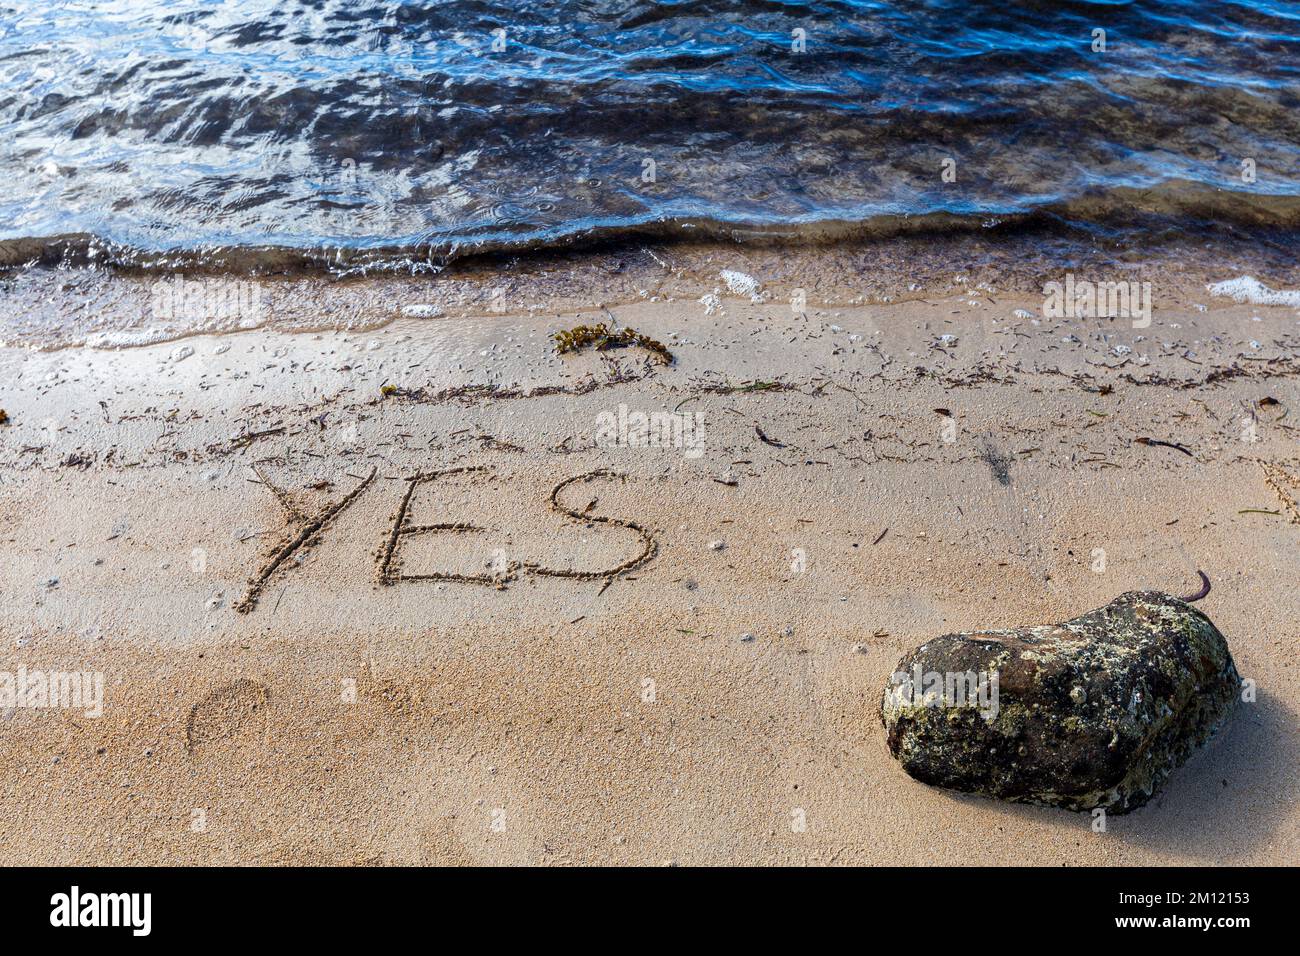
(0, 0, 1300, 271)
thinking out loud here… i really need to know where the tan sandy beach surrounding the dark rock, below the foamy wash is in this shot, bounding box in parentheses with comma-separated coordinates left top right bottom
(0, 264, 1300, 865)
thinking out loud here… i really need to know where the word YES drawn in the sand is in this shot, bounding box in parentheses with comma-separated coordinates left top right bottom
(235, 466, 658, 613)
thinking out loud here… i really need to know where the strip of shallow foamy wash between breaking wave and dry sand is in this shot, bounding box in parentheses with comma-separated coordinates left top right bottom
(0, 233, 1300, 350)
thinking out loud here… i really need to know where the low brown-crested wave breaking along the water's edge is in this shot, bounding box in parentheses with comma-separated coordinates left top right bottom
(0, 182, 1300, 278)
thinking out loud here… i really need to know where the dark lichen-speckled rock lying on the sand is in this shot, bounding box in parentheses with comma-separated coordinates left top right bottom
(880, 591, 1242, 813)
